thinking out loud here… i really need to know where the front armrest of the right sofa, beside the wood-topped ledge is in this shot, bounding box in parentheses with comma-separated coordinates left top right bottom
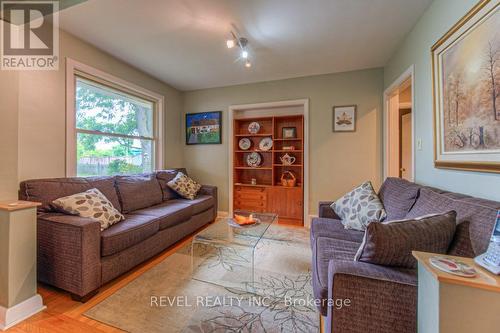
(327, 260, 417, 332)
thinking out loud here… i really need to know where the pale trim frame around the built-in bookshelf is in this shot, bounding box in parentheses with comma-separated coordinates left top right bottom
(227, 98, 310, 227)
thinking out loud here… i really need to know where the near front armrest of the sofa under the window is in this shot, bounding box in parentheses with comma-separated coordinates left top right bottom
(37, 214, 101, 297)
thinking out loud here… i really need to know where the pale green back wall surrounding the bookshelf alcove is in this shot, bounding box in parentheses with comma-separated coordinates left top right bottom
(184, 68, 383, 214)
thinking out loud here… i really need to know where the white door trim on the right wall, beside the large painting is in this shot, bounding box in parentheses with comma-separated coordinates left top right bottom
(382, 65, 416, 181)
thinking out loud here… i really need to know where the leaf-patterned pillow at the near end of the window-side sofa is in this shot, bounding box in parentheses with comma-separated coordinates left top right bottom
(53, 188, 125, 231)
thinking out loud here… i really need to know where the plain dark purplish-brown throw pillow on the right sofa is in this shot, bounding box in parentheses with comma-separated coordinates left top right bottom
(354, 211, 457, 268)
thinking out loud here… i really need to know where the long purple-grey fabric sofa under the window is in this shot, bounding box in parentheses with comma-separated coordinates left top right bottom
(19, 169, 217, 301)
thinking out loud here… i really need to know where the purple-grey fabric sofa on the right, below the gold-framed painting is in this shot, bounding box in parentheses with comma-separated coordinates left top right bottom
(311, 178, 500, 333)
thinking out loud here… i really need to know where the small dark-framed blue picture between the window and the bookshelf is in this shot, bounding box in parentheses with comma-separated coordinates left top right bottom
(186, 111, 222, 145)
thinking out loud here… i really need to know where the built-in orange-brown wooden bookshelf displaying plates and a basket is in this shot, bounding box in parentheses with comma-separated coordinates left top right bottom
(233, 115, 304, 225)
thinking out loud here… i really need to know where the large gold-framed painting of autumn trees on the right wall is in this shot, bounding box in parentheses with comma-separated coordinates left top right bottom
(431, 0, 500, 172)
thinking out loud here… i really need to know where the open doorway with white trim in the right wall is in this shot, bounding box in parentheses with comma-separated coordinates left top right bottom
(384, 67, 415, 181)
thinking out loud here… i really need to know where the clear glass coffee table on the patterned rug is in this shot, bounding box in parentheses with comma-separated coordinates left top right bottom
(191, 211, 278, 290)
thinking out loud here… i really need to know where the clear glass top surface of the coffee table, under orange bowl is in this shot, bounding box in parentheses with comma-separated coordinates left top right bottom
(194, 211, 278, 247)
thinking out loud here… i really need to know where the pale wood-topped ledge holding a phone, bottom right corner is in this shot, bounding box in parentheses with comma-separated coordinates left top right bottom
(413, 251, 500, 333)
